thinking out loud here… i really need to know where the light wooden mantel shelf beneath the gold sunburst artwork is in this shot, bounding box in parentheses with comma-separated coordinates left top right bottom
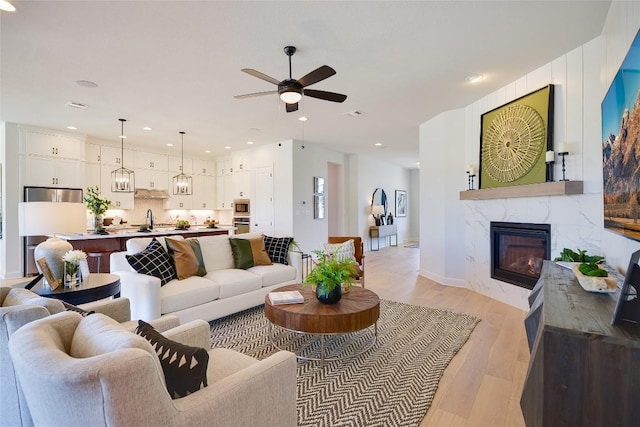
(460, 181, 582, 200)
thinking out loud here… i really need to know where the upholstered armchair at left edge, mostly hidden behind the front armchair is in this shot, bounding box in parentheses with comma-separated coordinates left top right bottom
(0, 287, 180, 427)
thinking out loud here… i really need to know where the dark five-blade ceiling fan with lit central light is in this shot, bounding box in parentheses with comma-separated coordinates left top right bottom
(234, 46, 347, 113)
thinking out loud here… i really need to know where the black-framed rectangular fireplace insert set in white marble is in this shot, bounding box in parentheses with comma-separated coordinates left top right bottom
(490, 222, 551, 289)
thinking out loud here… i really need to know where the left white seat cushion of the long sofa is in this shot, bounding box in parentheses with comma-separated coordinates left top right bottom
(160, 276, 220, 314)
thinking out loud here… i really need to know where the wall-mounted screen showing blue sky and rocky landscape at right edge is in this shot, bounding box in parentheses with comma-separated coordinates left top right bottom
(602, 32, 640, 240)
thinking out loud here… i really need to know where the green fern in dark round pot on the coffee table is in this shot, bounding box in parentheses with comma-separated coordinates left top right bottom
(303, 244, 358, 304)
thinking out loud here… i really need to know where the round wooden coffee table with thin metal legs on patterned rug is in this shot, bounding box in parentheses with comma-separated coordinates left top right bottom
(264, 285, 380, 364)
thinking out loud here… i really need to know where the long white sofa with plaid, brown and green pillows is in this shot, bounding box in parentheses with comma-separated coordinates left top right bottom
(111, 233, 302, 323)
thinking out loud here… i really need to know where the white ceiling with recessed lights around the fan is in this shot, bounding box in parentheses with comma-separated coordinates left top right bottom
(0, 0, 610, 168)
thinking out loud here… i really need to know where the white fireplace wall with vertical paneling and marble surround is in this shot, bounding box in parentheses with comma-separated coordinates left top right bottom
(420, 2, 640, 310)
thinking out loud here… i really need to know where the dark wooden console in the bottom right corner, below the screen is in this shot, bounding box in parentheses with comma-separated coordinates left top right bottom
(520, 261, 640, 427)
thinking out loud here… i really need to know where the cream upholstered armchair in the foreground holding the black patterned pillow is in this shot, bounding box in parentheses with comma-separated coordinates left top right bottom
(9, 312, 297, 427)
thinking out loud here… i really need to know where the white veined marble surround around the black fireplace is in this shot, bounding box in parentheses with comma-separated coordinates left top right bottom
(461, 181, 603, 311)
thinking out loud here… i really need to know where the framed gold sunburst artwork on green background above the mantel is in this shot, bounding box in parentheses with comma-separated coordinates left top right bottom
(480, 85, 553, 188)
